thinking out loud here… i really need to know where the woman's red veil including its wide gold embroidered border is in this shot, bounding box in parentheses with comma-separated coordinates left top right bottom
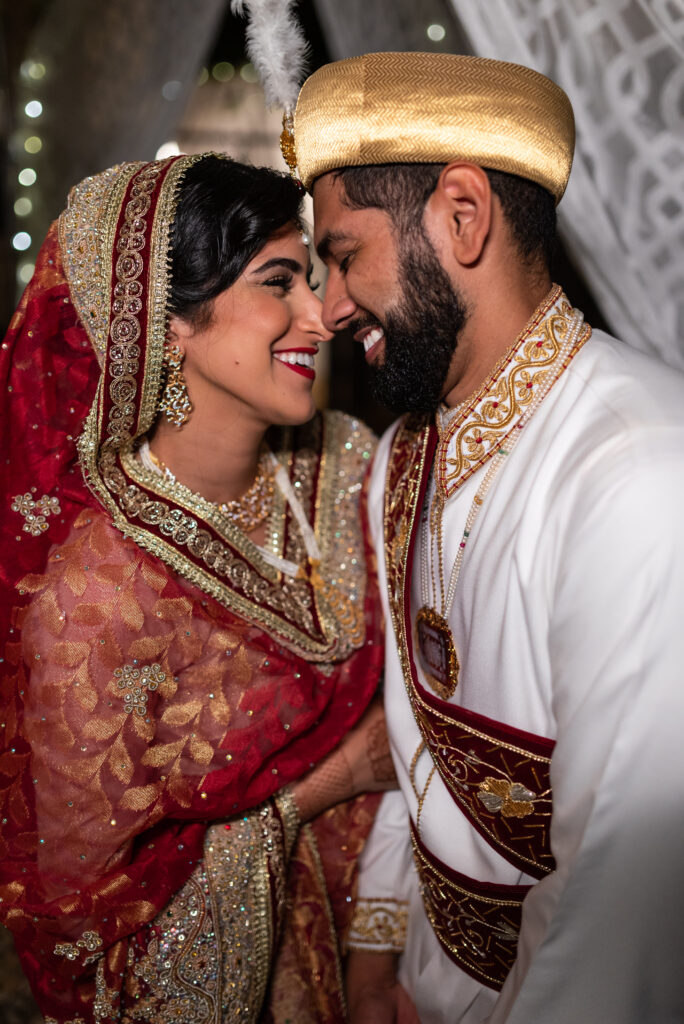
(0, 158, 382, 1020)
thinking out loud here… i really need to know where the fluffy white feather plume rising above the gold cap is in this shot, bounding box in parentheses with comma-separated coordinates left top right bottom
(230, 0, 308, 112)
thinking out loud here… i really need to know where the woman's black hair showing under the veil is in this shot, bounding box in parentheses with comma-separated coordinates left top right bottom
(168, 156, 302, 327)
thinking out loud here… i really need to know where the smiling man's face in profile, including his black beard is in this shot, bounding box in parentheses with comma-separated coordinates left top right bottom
(313, 174, 466, 412)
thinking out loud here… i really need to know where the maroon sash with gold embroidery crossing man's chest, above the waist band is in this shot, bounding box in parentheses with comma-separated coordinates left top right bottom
(385, 418, 554, 878)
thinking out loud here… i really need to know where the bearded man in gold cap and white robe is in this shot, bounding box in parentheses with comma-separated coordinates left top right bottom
(294, 53, 684, 1024)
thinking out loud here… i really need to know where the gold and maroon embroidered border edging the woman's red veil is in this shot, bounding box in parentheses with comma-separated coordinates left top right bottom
(59, 155, 372, 662)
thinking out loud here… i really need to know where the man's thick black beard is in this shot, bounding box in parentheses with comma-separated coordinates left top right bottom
(370, 232, 468, 413)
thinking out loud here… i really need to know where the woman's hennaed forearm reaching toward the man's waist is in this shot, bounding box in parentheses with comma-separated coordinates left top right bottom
(293, 699, 396, 821)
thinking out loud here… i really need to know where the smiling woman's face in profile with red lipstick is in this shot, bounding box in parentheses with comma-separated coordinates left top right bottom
(169, 225, 332, 429)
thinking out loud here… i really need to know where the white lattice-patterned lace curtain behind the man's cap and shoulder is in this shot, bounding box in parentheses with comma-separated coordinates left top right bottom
(450, 0, 684, 369)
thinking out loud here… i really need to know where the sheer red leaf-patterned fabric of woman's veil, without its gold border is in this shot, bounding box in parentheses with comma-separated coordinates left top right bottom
(0, 163, 382, 1020)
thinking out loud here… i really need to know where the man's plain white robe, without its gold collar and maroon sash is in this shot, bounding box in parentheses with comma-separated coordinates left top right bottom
(359, 332, 684, 1024)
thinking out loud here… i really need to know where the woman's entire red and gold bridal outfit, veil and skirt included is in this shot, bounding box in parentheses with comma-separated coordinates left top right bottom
(0, 158, 382, 1024)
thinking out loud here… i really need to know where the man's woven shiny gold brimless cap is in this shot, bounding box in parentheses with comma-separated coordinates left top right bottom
(295, 53, 574, 203)
